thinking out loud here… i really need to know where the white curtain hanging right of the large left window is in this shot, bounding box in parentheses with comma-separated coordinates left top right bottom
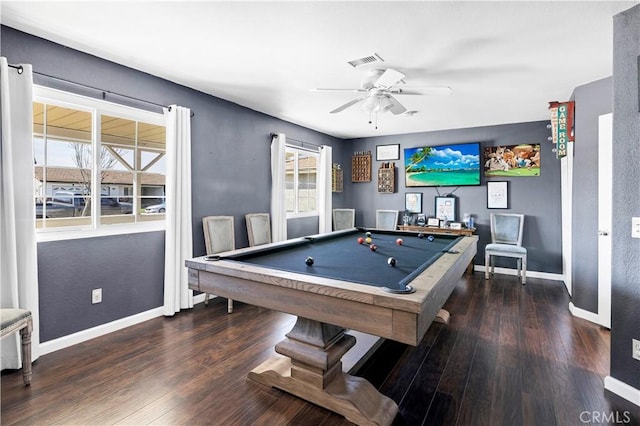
(164, 105, 193, 316)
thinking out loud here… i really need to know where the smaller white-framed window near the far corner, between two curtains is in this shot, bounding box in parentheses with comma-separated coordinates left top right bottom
(285, 146, 319, 217)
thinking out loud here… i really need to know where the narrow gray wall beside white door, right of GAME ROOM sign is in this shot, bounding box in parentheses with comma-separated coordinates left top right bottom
(571, 77, 613, 313)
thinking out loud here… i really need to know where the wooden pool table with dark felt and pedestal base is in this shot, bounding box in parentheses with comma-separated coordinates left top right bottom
(186, 228, 477, 424)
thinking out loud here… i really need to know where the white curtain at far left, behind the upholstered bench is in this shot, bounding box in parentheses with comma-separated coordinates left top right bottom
(0, 57, 40, 369)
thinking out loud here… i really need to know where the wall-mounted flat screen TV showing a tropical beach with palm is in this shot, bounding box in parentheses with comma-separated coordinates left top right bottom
(404, 142, 480, 187)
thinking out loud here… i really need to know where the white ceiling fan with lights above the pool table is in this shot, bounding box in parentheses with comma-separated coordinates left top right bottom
(317, 68, 451, 115)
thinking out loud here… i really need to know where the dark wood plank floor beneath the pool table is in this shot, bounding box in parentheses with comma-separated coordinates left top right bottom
(0, 273, 640, 426)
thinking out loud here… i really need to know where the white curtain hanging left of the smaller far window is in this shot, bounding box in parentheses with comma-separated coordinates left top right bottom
(271, 133, 287, 242)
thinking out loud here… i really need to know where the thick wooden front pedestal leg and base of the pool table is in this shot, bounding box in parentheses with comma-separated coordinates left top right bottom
(249, 317, 398, 425)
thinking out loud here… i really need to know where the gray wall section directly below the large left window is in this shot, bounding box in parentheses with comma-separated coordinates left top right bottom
(38, 232, 164, 342)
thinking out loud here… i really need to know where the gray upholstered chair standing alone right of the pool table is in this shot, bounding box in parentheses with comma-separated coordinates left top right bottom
(484, 213, 527, 285)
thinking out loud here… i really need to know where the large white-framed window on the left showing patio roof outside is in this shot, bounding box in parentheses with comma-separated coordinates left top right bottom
(33, 87, 166, 236)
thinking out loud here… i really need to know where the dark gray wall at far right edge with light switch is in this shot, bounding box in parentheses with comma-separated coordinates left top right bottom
(611, 5, 640, 390)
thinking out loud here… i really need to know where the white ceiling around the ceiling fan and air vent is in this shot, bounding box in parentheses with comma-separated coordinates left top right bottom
(0, 0, 638, 138)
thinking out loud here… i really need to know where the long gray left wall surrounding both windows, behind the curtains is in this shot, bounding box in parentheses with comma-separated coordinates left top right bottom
(0, 26, 348, 342)
